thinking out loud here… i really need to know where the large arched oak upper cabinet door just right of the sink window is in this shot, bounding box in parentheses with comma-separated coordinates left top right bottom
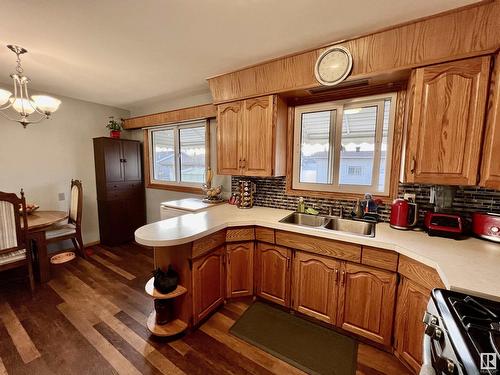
(405, 56, 490, 185)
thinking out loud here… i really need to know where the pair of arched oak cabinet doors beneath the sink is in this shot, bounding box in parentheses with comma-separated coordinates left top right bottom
(292, 251, 397, 346)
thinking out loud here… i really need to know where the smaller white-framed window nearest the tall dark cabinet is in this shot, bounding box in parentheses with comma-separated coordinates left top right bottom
(148, 121, 209, 188)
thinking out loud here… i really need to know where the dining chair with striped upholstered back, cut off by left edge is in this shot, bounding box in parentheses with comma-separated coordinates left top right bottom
(0, 190, 35, 291)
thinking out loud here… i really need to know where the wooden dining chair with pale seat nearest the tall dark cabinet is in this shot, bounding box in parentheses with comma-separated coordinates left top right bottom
(43, 180, 86, 258)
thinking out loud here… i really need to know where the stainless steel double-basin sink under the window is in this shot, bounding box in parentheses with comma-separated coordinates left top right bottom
(280, 212, 375, 237)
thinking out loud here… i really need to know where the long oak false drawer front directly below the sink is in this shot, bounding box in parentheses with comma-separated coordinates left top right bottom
(276, 230, 361, 263)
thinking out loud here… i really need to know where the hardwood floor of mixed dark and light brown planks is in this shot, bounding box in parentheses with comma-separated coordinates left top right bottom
(0, 244, 408, 375)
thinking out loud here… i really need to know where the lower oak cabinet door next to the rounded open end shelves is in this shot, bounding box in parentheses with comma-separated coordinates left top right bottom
(192, 246, 225, 324)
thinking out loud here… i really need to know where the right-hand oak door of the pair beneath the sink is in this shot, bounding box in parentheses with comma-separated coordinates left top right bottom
(337, 263, 397, 346)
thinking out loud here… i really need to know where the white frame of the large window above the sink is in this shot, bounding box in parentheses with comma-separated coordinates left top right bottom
(291, 92, 397, 197)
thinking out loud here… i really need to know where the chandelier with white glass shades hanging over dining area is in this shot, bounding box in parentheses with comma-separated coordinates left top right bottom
(0, 45, 61, 127)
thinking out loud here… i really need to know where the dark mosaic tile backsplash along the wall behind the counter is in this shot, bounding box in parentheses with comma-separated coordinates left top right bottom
(231, 176, 500, 221)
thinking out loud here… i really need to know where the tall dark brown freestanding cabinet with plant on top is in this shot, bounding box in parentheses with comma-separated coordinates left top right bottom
(94, 137, 146, 245)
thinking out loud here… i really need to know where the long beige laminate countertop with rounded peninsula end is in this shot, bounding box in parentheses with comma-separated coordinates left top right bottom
(135, 204, 500, 301)
